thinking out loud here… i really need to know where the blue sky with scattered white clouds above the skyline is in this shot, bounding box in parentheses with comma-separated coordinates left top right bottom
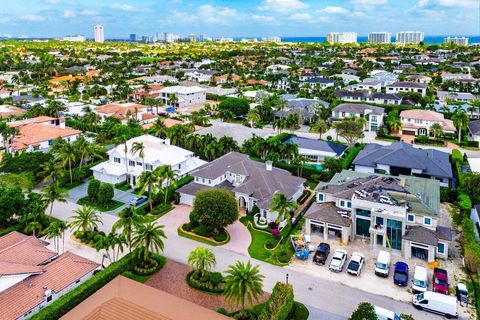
(0, 0, 480, 38)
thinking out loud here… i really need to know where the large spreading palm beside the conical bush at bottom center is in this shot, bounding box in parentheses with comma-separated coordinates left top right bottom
(224, 261, 264, 312)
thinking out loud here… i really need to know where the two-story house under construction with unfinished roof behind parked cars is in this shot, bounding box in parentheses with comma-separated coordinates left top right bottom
(304, 170, 452, 262)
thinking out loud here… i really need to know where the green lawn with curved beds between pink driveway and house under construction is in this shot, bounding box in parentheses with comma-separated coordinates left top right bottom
(240, 217, 303, 266)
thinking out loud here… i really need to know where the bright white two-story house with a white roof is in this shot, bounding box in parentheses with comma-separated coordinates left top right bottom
(92, 135, 206, 187)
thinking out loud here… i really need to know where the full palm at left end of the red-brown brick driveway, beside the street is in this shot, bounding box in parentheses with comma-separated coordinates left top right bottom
(132, 221, 167, 262)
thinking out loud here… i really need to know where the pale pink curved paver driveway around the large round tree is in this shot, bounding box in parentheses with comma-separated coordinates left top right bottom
(157, 205, 251, 256)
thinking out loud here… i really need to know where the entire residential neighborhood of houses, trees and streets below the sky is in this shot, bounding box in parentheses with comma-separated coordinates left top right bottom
(0, 22, 480, 320)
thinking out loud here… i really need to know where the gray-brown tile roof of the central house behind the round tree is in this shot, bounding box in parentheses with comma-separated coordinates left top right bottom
(191, 152, 305, 208)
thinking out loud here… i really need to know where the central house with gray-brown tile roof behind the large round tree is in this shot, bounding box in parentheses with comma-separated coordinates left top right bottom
(177, 152, 305, 227)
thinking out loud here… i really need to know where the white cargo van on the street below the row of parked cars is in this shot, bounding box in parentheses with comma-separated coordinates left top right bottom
(412, 291, 458, 319)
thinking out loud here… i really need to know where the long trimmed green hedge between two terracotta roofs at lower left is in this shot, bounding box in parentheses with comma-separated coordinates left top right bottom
(30, 254, 135, 320)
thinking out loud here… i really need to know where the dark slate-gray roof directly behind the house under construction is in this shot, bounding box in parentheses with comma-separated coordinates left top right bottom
(352, 141, 453, 179)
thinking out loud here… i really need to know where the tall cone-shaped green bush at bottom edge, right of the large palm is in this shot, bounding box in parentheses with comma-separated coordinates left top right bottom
(258, 282, 294, 320)
